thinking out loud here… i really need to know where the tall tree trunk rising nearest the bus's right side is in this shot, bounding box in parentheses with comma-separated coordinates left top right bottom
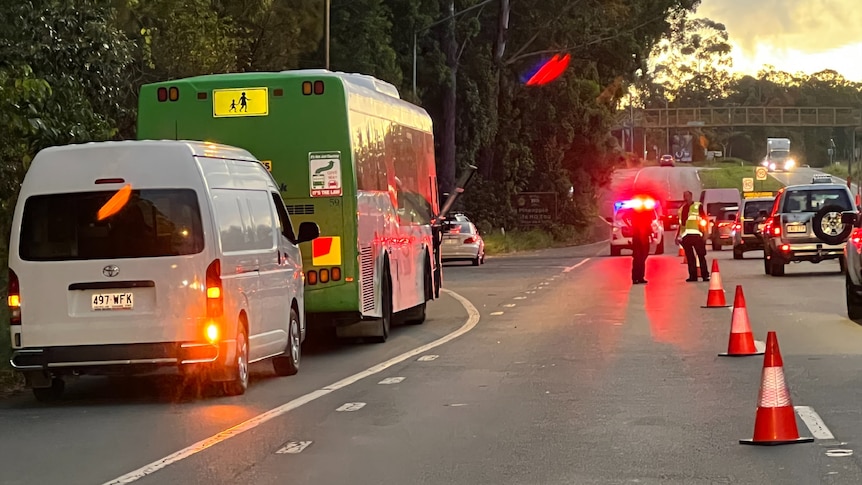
(438, 0, 458, 194)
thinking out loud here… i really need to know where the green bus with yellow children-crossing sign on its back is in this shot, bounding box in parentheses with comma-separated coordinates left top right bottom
(137, 70, 442, 342)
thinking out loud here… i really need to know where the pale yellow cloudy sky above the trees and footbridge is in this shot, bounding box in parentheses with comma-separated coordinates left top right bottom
(696, 0, 862, 81)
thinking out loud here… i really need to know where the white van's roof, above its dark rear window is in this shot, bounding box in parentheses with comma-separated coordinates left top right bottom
(21, 140, 266, 196)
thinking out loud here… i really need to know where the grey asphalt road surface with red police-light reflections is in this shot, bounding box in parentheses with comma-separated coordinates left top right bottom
(0, 168, 862, 485)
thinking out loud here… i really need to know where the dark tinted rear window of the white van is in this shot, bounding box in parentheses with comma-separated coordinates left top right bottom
(18, 189, 204, 261)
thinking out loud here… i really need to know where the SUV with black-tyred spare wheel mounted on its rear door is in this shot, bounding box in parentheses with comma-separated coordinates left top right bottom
(763, 184, 855, 276)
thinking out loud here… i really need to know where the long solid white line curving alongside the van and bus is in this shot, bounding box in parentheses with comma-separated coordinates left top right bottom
(104, 288, 480, 485)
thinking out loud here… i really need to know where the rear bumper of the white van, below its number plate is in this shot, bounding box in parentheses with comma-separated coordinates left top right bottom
(10, 342, 219, 372)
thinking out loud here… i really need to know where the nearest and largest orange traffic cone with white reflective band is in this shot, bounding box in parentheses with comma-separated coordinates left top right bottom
(739, 332, 814, 445)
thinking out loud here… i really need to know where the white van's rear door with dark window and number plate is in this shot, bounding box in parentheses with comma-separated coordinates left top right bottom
(15, 185, 206, 347)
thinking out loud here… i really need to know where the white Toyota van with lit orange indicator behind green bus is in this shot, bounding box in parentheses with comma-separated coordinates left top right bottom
(8, 141, 319, 400)
